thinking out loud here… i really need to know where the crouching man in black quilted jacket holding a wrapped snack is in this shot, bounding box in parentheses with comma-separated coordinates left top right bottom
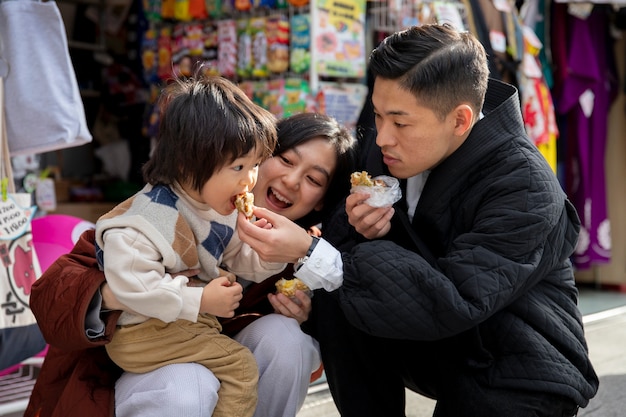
(310, 25, 598, 417)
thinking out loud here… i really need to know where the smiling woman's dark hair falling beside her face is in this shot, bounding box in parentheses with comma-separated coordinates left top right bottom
(274, 113, 356, 228)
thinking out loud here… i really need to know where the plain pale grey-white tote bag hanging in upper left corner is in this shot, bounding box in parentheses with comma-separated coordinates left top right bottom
(0, 0, 92, 156)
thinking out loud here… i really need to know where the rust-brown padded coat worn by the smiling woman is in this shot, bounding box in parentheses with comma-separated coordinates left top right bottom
(24, 230, 121, 417)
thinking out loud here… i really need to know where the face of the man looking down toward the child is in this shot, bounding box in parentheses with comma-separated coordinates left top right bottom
(372, 77, 460, 178)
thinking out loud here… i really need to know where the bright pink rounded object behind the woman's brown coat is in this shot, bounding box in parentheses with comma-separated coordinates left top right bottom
(32, 214, 95, 271)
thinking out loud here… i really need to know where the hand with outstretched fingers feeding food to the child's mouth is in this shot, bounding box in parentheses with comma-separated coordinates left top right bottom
(237, 207, 313, 263)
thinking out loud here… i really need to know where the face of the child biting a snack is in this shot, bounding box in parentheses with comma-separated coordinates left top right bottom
(186, 150, 261, 216)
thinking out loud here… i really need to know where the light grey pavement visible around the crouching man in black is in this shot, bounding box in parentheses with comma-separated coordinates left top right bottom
(297, 307, 626, 417)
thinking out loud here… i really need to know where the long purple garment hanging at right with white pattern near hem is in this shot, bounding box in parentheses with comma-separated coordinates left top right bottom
(557, 6, 618, 269)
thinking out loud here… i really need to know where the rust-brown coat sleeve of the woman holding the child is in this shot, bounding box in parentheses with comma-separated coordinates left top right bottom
(30, 230, 120, 350)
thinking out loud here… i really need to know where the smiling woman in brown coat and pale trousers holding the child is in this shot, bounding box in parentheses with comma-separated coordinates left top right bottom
(24, 113, 355, 417)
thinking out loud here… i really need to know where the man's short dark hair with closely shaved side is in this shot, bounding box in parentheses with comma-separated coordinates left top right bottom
(369, 24, 489, 118)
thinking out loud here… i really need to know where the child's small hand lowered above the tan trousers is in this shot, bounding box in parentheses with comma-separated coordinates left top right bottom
(200, 277, 243, 317)
